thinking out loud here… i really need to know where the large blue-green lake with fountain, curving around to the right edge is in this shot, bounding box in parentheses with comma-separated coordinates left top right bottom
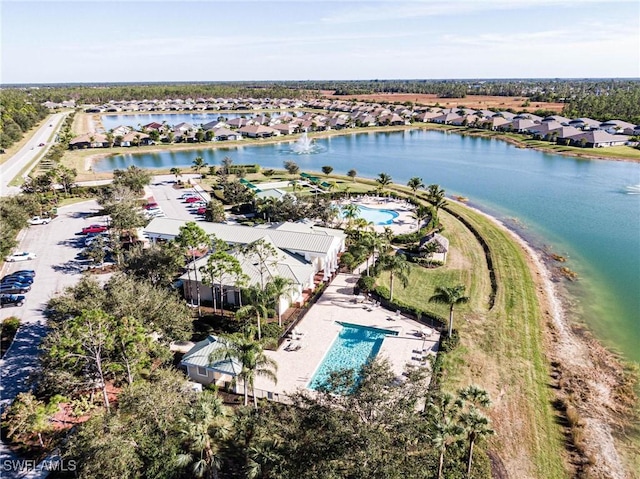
(95, 130, 640, 361)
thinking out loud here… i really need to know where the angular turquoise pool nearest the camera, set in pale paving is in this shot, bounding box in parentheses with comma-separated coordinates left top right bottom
(307, 322, 398, 389)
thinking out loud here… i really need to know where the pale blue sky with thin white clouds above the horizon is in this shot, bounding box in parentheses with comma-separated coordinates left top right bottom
(0, 0, 640, 83)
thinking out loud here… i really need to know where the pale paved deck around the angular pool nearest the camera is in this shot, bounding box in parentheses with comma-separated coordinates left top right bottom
(255, 274, 439, 395)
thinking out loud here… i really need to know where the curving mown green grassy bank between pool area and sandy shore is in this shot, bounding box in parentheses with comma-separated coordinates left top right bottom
(380, 201, 569, 479)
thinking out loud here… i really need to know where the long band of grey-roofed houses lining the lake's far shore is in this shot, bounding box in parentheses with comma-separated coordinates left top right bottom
(70, 99, 640, 148)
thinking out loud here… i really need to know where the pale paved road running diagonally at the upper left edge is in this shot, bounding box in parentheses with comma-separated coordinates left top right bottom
(0, 112, 68, 196)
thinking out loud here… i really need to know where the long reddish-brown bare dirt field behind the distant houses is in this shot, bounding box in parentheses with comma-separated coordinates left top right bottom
(322, 91, 564, 112)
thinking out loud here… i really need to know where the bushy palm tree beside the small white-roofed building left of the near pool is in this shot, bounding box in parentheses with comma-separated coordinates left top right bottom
(209, 331, 278, 409)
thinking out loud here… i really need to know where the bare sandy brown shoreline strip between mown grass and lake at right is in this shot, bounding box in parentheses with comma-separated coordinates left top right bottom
(453, 200, 633, 479)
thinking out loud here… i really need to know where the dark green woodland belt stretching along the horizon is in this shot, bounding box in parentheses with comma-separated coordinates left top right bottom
(0, 79, 640, 148)
